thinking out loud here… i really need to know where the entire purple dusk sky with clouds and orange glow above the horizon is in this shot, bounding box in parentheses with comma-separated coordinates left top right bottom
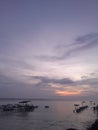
(0, 0, 98, 99)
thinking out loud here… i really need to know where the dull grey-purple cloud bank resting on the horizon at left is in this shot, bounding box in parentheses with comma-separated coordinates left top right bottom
(0, 74, 54, 98)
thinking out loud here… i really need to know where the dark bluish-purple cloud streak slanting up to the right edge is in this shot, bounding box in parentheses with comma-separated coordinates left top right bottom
(56, 33, 98, 60)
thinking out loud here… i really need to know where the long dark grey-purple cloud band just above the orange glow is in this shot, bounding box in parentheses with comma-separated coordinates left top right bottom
(26, 73, 98, 87)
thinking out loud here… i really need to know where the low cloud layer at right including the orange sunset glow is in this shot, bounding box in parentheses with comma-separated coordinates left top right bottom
(28, 76, 98, 96)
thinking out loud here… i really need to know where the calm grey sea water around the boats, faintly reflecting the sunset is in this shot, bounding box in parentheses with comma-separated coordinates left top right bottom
(0, 100, 97, 130)
